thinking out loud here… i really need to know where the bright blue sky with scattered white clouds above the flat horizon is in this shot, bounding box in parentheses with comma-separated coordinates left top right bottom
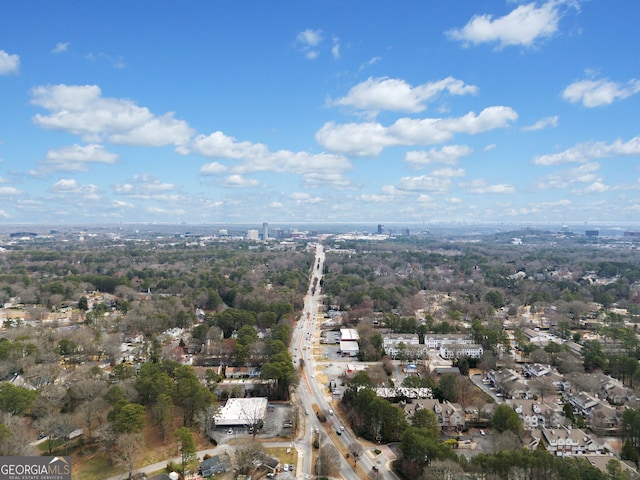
(0, 0, 640, 224)
